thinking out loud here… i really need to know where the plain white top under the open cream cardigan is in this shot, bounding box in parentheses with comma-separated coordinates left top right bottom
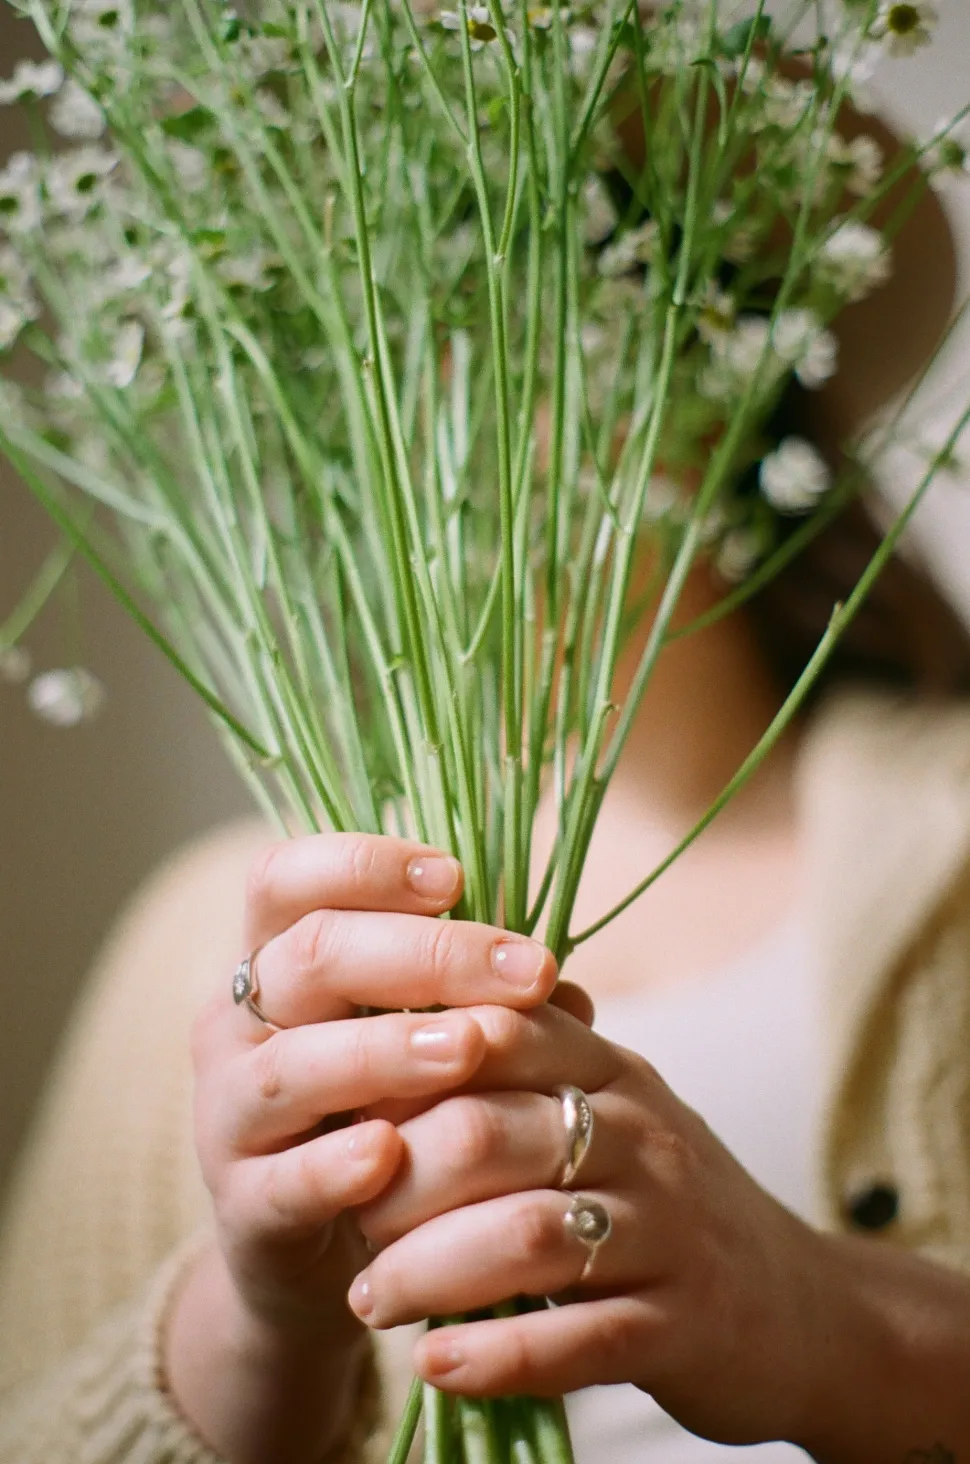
(568, 915, 822, 1464)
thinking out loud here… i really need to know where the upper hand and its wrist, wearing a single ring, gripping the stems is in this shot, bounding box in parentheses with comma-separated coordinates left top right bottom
(167, 834, 556, 1460)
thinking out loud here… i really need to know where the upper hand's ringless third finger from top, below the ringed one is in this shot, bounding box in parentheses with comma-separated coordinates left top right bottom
(214, 1012, 486, 1155)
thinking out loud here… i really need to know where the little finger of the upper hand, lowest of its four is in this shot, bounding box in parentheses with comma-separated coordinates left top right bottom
(224, 1118, 404, 1241)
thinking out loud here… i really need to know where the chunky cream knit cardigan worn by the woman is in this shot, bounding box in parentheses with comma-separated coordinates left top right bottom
(0, 695, 970, 1464)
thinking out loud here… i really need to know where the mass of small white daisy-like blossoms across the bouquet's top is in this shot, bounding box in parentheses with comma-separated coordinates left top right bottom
(0, 0, 970, 635)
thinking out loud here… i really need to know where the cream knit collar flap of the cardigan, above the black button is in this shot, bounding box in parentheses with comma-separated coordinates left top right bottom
(797, 692, 970, 1082)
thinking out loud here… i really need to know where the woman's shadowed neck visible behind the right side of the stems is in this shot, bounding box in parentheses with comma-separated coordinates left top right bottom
(612, 553, 794, 832)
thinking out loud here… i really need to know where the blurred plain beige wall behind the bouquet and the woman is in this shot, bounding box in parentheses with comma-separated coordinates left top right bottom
(0, 0, 970, 1187)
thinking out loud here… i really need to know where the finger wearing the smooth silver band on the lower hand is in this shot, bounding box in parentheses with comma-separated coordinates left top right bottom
(358, 1092, 635, 1247)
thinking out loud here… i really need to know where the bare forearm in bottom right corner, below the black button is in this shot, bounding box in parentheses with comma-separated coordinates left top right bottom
(793, 1236, 970, 1464)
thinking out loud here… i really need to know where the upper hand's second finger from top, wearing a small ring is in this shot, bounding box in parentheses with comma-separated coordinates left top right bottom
(241, 909, 556, 1038)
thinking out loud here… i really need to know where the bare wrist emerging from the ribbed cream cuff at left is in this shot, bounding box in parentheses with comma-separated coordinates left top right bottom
(164, 1244, 370, 1464)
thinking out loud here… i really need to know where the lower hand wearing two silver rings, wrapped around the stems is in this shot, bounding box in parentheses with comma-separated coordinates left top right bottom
(350, 1004, 832, 1444)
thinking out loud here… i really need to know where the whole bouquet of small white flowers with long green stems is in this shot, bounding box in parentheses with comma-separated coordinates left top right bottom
(0, 0, 970, 1464)
